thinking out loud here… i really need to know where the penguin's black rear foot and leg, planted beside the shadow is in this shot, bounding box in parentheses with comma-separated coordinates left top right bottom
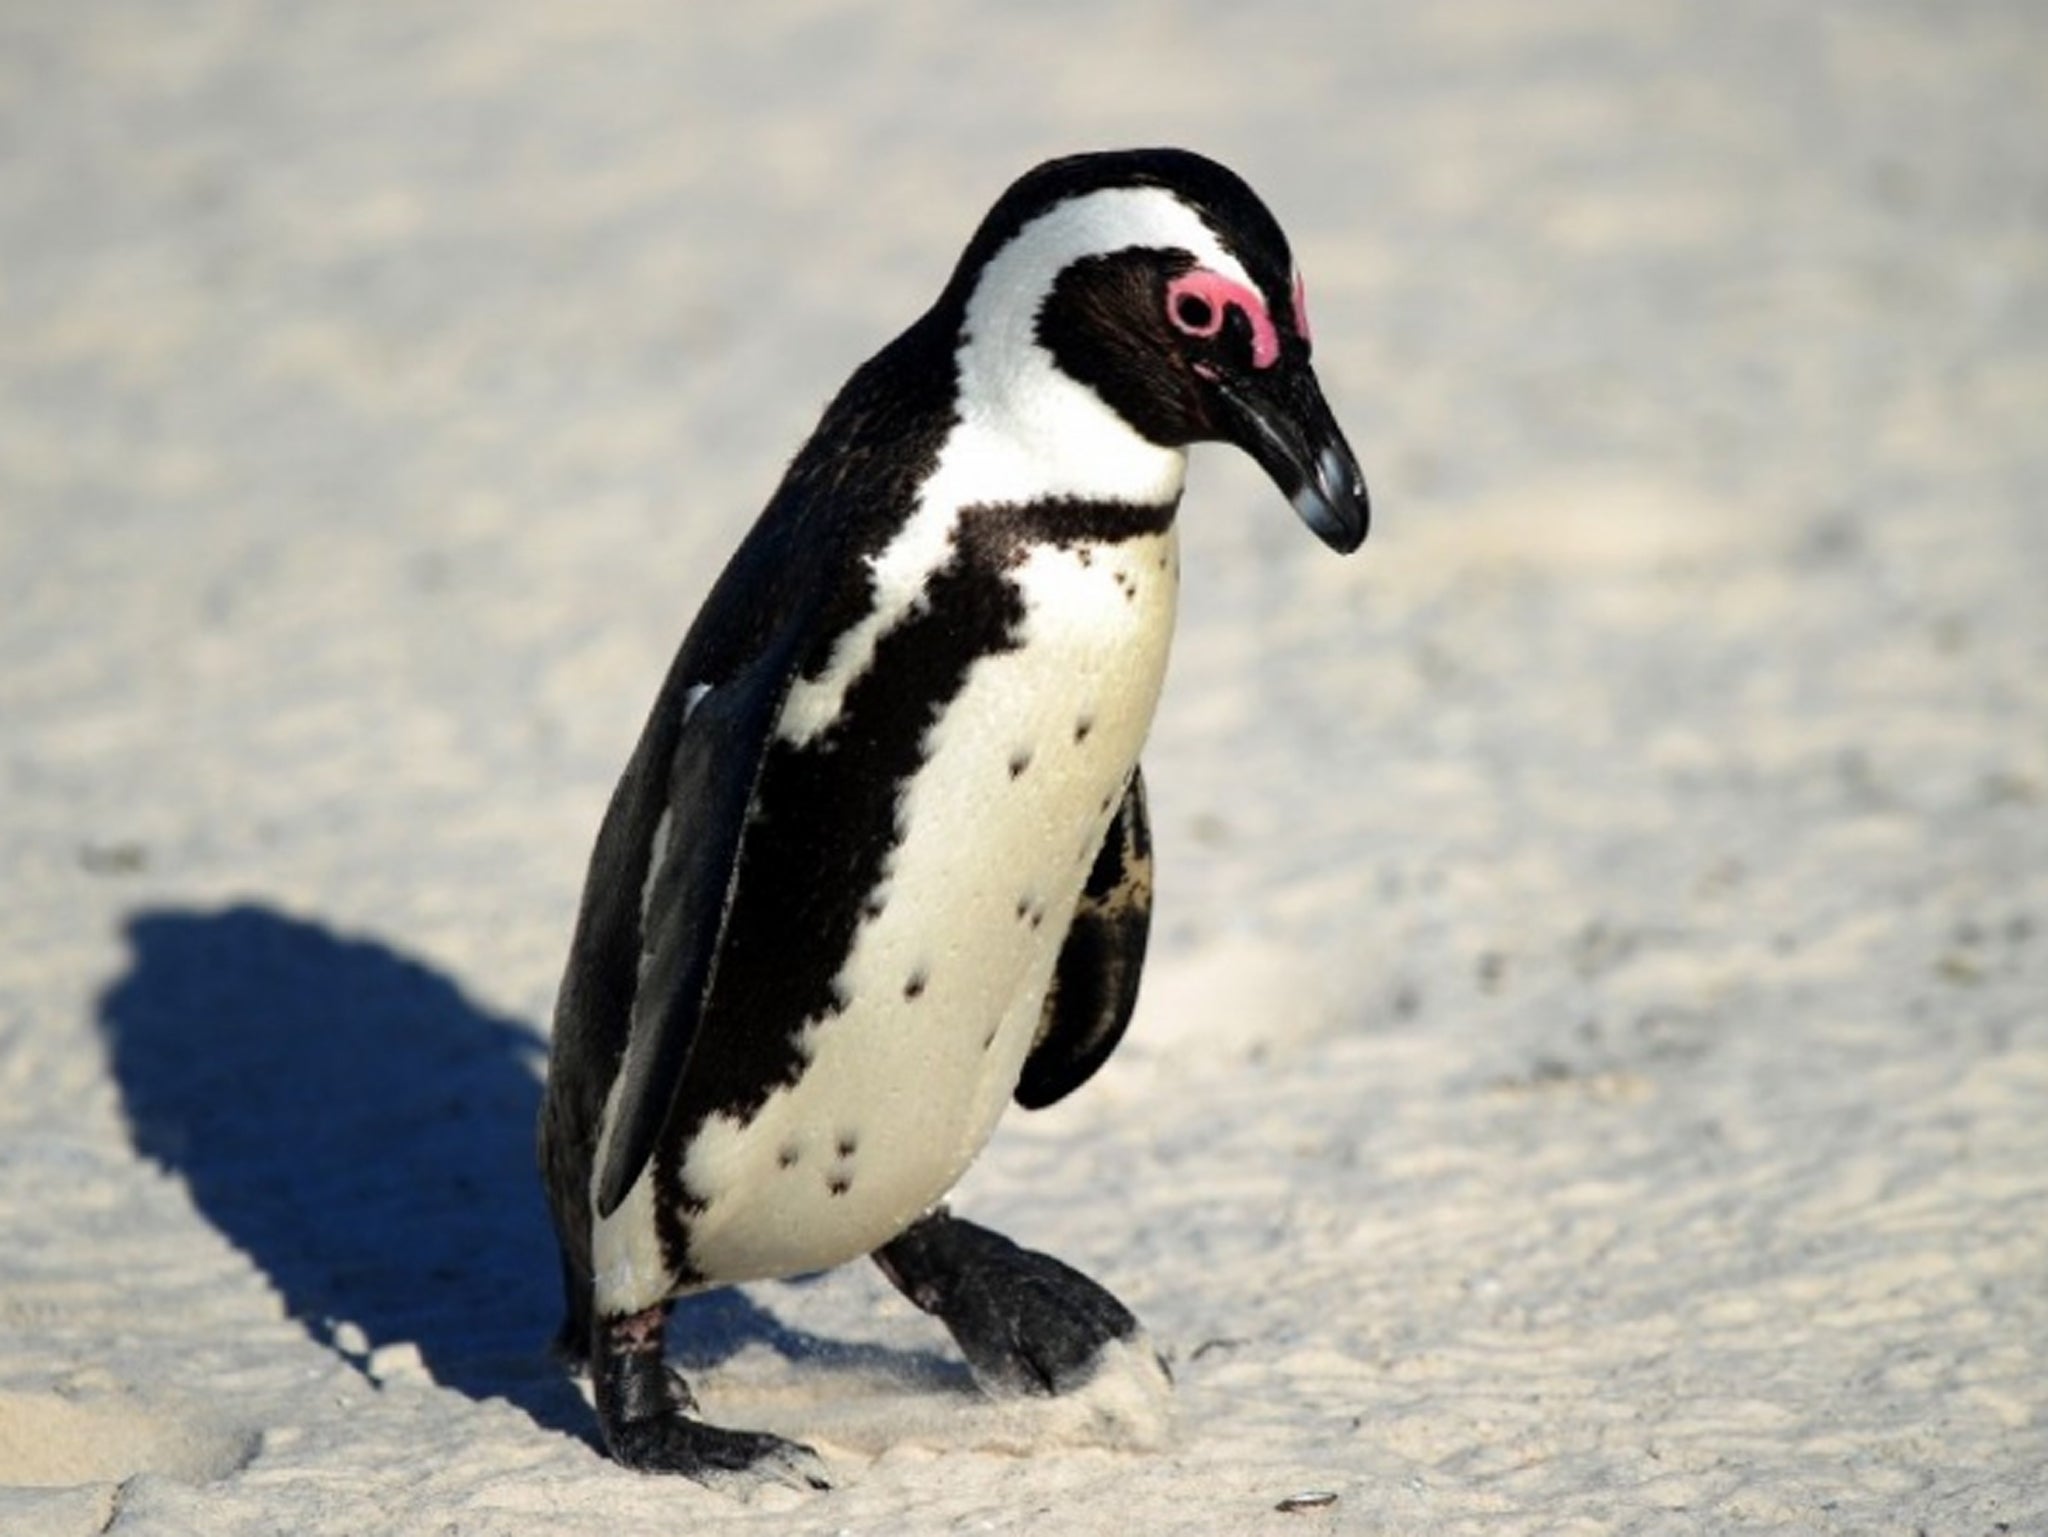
(590, 1303, 831, 1490)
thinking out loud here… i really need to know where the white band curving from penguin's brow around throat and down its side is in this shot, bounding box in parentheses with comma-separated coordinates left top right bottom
(778, 186, 1212, 746)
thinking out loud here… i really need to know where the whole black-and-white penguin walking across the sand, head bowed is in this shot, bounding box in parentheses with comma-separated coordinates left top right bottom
(539, 150, 1368, 1488)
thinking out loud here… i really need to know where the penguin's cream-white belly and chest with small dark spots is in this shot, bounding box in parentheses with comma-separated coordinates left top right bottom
(682, 529, 1178, 1283)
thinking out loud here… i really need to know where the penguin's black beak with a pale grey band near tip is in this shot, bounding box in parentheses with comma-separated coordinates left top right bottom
(1212, 358, 1372, 555)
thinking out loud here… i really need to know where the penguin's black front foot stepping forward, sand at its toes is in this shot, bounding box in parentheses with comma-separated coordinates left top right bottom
(874, 1207, 1165, 1398)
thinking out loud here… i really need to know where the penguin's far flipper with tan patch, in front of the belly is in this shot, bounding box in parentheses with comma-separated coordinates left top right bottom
(1016, 769, 1151, 1111)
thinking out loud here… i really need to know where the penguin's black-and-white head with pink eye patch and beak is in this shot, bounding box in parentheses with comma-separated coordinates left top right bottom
(942, 150, 1368, 553)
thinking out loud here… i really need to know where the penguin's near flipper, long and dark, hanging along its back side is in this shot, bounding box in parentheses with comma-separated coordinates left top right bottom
(598, 654, 795, 1217)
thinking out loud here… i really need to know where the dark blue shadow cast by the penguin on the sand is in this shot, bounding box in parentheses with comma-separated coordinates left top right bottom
(100, 906, 946, 1441)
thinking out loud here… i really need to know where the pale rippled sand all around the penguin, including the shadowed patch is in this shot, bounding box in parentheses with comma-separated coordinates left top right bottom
(0, 0, 2048, 1537)
